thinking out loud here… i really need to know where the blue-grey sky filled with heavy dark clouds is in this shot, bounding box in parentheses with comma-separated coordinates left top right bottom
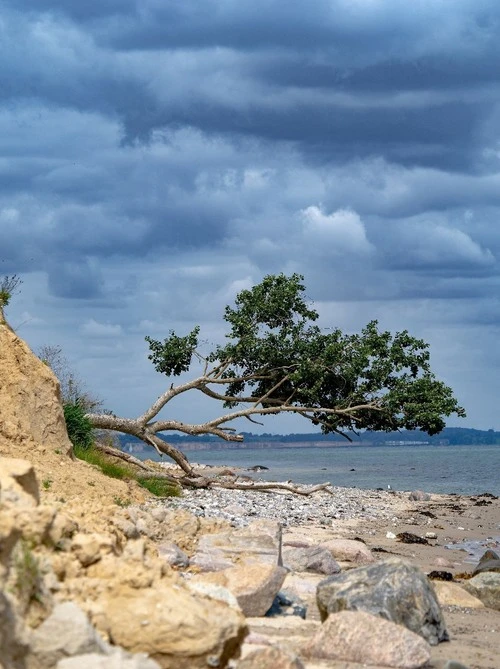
(0, 0, 500, 432)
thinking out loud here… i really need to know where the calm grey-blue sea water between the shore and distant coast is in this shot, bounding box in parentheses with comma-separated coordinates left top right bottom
(163, 446, 500, 495)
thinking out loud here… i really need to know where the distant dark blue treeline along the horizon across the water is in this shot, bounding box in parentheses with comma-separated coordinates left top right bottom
(118, 427, 500, 448)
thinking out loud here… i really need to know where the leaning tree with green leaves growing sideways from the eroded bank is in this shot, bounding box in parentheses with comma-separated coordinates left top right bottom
(87, 274, 465, 487)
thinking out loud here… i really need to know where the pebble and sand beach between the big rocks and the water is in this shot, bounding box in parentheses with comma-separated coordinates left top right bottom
(153, 466, 500, 669)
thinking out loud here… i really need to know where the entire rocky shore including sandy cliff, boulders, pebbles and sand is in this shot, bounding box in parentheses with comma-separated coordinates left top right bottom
(0, 310, 500, 669)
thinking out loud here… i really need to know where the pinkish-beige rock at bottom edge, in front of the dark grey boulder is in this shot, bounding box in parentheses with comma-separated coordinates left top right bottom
(303, 611, 431, 669)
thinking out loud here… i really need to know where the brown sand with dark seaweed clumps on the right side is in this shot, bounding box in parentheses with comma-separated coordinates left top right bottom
(287, 493, 500, 669)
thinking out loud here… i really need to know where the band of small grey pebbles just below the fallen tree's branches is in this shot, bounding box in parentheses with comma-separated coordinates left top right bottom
(154, 487, 404, 527)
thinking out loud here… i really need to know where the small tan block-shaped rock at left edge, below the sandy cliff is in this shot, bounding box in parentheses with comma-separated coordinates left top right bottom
(0, 460, 40, 507)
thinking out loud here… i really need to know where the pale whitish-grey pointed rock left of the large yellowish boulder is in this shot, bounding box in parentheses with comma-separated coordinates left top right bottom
(31, 602, 108, 669)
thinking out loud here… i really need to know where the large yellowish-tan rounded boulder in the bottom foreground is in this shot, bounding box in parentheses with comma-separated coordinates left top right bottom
(96, 582, 247, 669)
